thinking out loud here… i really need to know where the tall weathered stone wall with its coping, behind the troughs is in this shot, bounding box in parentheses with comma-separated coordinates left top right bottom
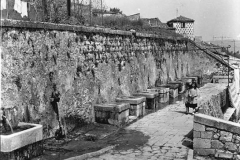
(1, 20, 223, 137)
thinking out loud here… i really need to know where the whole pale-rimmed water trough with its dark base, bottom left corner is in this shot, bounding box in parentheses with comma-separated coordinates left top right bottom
(0, 122, 43, 159)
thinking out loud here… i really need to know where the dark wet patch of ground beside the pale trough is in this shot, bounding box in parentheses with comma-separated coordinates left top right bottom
(34, 119, 149, 160)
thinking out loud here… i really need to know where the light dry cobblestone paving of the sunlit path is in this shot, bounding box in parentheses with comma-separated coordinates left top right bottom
(91, 102, 193, 160)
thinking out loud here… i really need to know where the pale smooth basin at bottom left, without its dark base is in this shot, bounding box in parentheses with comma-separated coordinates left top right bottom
(0, 122, 43, 152)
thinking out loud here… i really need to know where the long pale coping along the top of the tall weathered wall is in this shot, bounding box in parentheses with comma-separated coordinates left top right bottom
(1, 19, 187, 41)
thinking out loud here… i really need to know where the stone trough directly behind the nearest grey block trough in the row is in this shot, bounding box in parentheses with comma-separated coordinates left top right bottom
(116, 96, 146, 117)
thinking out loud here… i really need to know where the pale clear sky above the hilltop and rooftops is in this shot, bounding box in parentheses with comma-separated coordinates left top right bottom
(104, 0, 240, 41)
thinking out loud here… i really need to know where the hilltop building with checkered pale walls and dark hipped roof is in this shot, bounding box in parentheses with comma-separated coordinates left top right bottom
(167, 16, 194, 40)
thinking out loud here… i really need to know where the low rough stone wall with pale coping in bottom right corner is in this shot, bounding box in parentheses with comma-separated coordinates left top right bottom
(193, 114, 240, 159)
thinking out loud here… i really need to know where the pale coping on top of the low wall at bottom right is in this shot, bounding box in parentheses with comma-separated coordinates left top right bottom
(194, 113, 240, 134)
